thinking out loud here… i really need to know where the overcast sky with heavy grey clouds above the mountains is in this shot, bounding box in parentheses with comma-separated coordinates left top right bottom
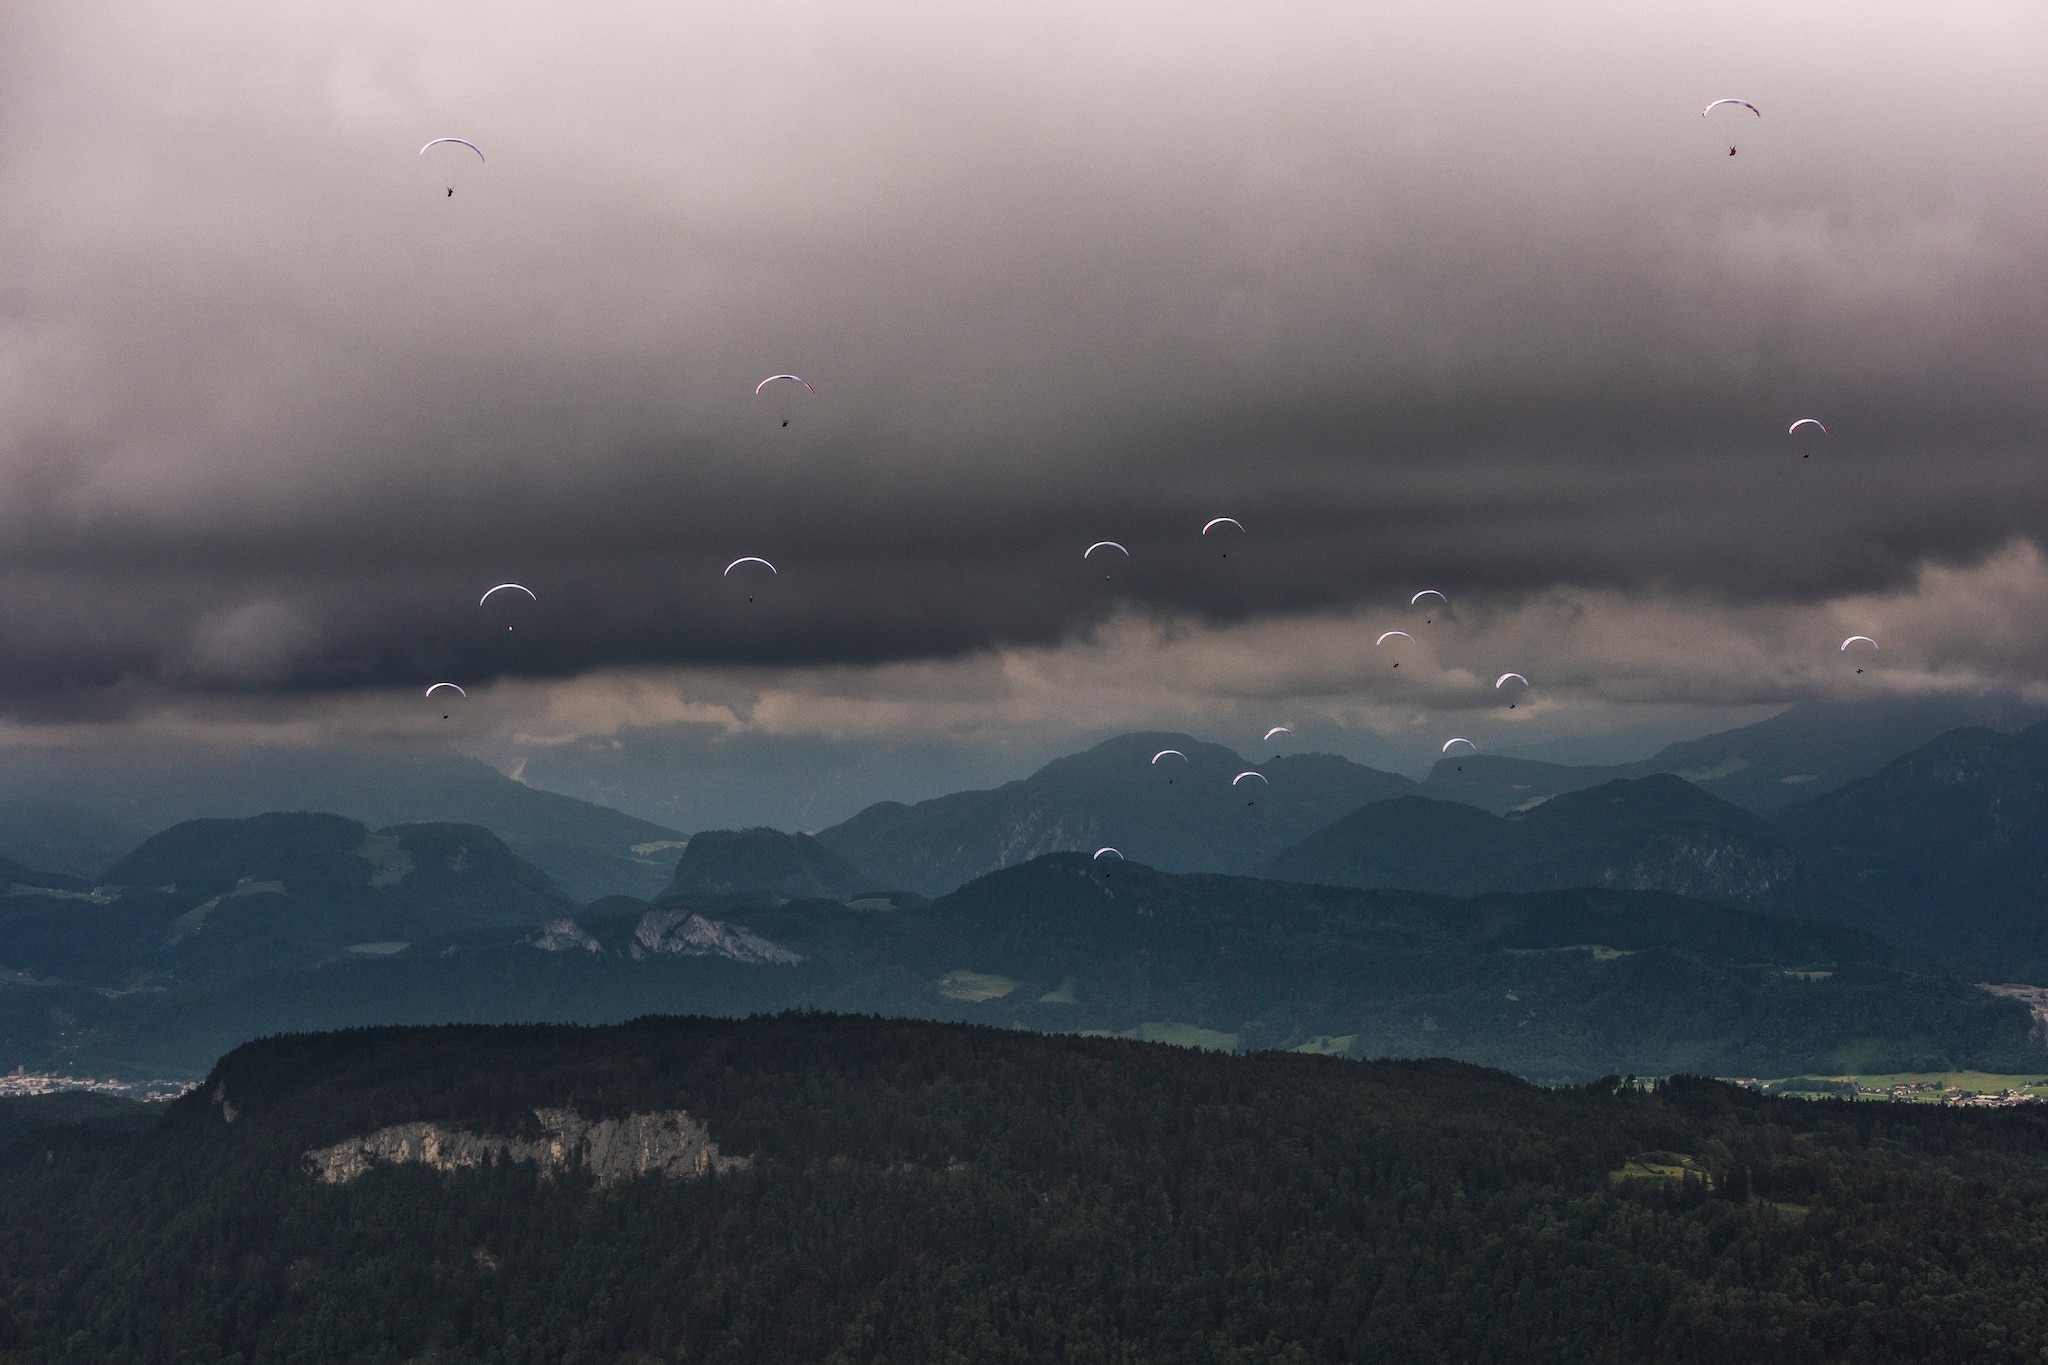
(0, 0, 2048, 785)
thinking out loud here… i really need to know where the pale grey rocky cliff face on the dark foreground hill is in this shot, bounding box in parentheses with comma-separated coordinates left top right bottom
(305, 1109, 750, 1189)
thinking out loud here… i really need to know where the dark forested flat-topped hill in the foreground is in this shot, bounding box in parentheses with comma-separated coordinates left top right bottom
(12, 1015, 2048, 1363)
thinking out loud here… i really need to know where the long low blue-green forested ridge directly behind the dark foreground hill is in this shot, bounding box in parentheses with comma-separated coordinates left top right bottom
(12, 853, 2048, 1081)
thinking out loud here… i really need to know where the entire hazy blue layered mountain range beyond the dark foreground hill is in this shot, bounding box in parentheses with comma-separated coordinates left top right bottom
(0, 695, 2048, 1078)
